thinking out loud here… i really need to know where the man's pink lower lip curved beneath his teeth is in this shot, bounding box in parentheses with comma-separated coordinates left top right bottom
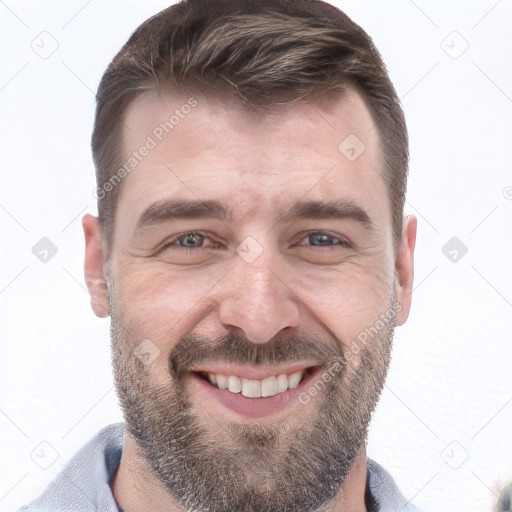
(191, 368, 318, 418)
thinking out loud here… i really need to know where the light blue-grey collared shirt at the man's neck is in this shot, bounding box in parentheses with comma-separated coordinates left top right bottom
(19, 423, 421, 512)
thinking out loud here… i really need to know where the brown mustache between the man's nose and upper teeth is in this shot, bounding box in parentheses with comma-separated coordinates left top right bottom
(169, 333, 342, 377)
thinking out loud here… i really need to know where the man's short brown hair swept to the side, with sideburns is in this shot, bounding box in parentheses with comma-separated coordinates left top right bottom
(92, 0, 409, 252)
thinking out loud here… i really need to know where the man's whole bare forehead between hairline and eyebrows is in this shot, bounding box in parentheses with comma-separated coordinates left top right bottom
(116, 89, 387, 236)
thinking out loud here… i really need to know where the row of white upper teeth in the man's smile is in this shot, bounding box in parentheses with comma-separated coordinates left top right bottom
(207, 370, 304, 398)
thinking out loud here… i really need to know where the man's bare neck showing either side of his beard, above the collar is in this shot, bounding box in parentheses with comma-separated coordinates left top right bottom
(110, 431, 367, 512)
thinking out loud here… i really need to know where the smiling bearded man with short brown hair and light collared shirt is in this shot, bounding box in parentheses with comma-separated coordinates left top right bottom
(23, 0, 417, 512)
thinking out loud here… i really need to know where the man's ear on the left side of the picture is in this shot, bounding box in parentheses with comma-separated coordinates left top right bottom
(82, 214, 110, 318)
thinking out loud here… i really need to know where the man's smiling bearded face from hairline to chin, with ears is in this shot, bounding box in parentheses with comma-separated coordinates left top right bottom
(84, 86, 414, 512)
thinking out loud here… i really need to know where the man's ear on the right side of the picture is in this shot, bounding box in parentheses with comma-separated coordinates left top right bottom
(395, 215, 418, 325)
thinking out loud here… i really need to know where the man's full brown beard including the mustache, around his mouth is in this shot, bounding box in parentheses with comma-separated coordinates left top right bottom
(111, 294, 394, 512)
